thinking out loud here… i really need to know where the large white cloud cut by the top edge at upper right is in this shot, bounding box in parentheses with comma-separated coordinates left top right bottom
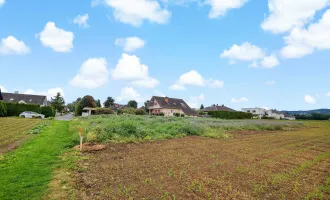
(261, 0, 330, 33)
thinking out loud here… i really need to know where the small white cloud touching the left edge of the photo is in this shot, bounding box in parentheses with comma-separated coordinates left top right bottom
(0, 36, 30, 55)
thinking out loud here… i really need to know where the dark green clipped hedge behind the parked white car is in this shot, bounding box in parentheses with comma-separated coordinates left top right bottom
(6, 102, 41, 116)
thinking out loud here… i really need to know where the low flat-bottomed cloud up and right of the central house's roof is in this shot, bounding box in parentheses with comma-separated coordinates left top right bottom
(169, 70, 224, 90)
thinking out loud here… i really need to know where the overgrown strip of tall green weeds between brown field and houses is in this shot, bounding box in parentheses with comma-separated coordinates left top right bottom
(71, 115, 299, 143)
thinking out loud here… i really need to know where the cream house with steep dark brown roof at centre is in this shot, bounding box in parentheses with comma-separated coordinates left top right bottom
(148, 96, 198, 116)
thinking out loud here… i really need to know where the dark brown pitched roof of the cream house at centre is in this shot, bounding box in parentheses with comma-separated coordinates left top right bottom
(148, 96, 197, 116)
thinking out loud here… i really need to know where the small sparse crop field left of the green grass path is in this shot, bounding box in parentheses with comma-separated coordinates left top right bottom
(0, 118, 41, 154)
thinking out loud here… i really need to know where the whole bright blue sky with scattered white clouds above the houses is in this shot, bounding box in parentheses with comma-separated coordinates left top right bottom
(0, 0, 330, 110)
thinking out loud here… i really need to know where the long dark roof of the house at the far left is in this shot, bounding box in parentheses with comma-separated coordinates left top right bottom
(2, 92, 47, 105)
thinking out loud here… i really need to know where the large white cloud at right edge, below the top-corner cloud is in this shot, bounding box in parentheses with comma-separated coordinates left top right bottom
(281, 10, 330, 58)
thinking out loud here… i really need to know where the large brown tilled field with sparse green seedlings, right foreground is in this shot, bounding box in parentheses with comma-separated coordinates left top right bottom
(73, 119, 330, 199)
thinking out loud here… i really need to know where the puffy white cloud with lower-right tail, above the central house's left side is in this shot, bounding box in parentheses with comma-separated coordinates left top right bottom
(111, 53, 159, 88)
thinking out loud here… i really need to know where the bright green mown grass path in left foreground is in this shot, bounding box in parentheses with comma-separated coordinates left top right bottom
(0, 121, 72, 200)
